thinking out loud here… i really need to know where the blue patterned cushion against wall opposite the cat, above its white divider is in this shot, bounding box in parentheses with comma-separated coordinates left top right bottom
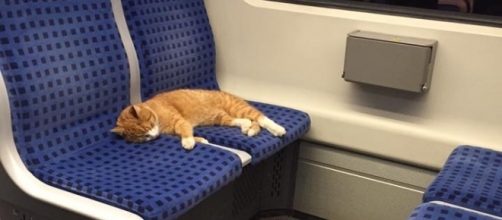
(424, 146, 502, 216)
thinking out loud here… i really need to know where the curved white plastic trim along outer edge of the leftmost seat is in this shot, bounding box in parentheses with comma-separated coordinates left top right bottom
(0, 72, 142, 220)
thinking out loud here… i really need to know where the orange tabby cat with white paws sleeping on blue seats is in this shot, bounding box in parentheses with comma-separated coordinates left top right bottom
(112, 89, 286, 150)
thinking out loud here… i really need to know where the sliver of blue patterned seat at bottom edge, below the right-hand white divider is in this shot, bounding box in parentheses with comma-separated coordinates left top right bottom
(408, 203, 497, 220)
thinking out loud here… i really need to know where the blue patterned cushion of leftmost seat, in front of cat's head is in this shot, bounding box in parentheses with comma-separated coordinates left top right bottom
(32, 137, 241, 219)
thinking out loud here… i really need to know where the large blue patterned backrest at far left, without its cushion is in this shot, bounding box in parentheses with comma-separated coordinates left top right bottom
(0, 0, 129, 169)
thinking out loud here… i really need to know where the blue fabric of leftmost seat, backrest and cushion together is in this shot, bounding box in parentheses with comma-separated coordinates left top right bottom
(0, 0, 241, 219)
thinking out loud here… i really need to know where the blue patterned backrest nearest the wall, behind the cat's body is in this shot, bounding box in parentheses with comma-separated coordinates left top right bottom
(122, 0, 218, 98)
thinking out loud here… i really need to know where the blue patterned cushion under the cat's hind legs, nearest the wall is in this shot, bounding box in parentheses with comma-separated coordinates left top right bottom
(195, 102, 310, 164)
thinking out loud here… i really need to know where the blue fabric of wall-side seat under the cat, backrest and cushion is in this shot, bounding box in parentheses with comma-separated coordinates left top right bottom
(123, 0, 310, 163)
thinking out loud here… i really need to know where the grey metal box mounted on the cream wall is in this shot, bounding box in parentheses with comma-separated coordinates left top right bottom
(342, 31, 437, 93)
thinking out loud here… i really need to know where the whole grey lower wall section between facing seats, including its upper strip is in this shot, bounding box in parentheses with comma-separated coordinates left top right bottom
(294, 142, 437, 220)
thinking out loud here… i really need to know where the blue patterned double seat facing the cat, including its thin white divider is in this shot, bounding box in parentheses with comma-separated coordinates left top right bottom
(409, 145, 502, 220)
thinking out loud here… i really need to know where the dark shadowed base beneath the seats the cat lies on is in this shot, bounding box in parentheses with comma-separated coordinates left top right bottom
(179, 141, 299, 220)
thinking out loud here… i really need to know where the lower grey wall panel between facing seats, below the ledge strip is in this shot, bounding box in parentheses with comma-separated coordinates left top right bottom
(294, 161, 422, 220)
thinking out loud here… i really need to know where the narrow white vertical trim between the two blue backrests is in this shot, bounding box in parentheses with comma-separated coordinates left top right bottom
(111, 0, 141, 104)
